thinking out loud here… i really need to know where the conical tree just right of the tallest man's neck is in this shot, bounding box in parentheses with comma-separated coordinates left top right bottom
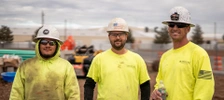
(191, 25, 204, 44)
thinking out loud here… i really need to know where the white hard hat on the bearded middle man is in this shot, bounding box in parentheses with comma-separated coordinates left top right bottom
(107, 18, 129, 33)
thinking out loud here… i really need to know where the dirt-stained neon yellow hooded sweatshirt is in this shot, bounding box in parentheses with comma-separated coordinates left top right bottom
(10, 42, 80, 100)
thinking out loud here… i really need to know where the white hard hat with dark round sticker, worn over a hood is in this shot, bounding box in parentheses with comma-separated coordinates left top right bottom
(34, 25, 63, 44)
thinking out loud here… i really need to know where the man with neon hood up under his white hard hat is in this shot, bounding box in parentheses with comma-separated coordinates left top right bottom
(10, 25, 80, 100)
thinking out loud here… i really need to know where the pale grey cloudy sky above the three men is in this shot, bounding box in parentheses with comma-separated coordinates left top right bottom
(0, 0, 224, 34)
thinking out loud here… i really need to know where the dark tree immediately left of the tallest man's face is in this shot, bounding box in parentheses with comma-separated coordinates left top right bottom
(153, 26, 171, 44)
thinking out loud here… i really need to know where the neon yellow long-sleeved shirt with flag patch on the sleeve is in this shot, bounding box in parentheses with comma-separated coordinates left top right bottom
(155, 42, 214, 100)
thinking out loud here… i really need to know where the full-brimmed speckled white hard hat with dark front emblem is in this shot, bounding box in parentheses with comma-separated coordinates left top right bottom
(162, 6, 195, 27)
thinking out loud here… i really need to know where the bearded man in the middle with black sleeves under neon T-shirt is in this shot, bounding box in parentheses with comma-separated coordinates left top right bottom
(84, 18, 150, 100)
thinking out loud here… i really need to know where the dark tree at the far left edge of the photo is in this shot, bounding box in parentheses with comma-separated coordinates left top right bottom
(0, 25, 14, 47)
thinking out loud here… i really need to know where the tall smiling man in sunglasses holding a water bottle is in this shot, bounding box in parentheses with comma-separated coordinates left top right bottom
(151, 6, 214, 100)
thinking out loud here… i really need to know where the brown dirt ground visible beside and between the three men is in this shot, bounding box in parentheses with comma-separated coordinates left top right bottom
(0, 71, 224, 100)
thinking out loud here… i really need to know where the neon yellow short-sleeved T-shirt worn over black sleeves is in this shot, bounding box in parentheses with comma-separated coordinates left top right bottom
(87, 49, 150, 100)
